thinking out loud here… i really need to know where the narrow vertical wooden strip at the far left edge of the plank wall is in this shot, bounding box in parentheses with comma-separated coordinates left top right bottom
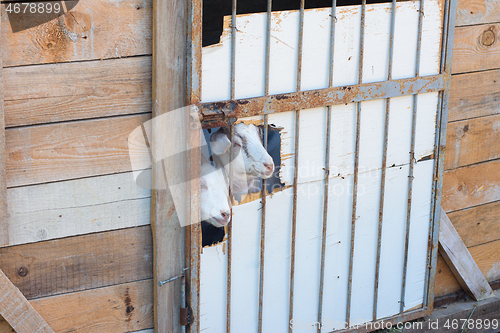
(0, 11, 9, 246)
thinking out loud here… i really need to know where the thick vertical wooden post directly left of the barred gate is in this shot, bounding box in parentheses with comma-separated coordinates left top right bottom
(151, 0, 188, 333)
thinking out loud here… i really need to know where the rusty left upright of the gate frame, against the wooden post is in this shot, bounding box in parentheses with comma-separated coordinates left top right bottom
(185, 0, 203, 333)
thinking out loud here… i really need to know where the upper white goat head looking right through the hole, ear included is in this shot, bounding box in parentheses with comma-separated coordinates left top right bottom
(210, 123, 274, 193)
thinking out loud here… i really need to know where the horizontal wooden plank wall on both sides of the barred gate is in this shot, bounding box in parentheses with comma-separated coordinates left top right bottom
(0, 0, 500, 333)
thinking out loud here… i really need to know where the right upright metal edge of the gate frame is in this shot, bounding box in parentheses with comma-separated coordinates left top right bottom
(424, 0, 457, 309)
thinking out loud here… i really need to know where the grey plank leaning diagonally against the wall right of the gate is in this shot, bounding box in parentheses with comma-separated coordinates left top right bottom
(439, 209, 494, 301)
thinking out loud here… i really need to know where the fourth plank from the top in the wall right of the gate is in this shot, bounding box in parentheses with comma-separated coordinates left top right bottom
(444, 115, 500, 170)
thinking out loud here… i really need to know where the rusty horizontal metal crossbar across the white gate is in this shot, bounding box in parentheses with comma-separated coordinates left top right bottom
(198, 74, 449, 118)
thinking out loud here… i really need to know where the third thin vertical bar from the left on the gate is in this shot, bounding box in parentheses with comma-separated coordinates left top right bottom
(288, 0, 305, 333)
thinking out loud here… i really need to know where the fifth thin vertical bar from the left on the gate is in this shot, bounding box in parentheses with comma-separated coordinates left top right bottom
(346, 0, 366, 325)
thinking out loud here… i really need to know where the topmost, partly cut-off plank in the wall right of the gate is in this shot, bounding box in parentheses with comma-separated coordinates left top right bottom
(455, 0, 500, 26)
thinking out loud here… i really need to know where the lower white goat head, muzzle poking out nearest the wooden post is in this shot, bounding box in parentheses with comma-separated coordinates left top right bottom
(200, 158, 231, 228)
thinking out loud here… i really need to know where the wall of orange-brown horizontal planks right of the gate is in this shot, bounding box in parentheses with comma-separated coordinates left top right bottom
(435, 0, 500, 296)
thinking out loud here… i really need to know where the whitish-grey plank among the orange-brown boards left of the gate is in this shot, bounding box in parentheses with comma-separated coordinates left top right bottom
(7, 172, 151, 245)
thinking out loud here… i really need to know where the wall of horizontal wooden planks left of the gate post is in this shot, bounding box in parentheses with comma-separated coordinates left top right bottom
(0, 0, 153, 333)
